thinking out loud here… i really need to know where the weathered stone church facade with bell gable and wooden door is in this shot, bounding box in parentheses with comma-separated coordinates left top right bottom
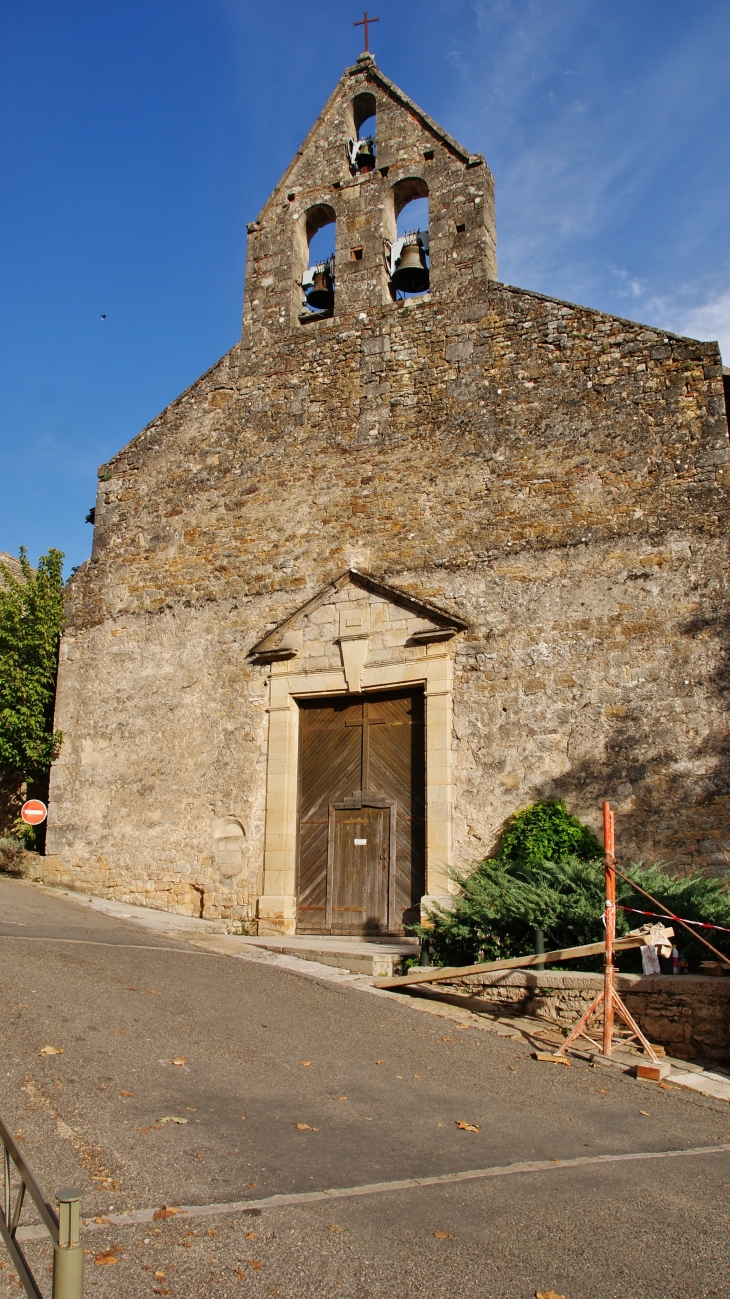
(47, 56, 730, 934)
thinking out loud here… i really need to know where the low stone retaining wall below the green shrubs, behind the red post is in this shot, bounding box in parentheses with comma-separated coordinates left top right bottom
(438, 970, 730, 1064)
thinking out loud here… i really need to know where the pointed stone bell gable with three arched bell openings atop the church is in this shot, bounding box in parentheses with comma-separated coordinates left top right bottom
(243, 53, 496, 347)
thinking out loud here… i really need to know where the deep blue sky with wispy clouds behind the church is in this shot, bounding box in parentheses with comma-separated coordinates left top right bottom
(0, 0, 730, 572)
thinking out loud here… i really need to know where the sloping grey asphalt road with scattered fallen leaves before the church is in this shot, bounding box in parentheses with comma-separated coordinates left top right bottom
(0, 877, 730, 1299)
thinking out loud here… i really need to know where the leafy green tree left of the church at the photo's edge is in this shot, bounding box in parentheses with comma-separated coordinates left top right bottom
(0, 547, 64, 781)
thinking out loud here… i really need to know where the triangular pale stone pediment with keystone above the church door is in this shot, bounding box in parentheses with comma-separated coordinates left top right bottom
(249, 569, 466, 690)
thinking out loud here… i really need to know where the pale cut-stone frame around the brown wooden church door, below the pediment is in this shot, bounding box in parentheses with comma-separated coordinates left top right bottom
(258, 644, 453, 935)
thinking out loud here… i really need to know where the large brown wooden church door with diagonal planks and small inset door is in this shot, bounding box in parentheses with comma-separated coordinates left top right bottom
(297, 690, 425, 934)
